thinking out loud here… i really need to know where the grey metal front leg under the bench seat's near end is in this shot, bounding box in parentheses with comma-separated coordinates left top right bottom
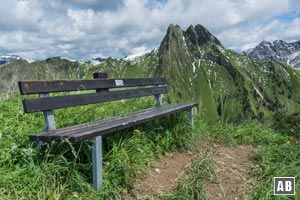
(92, 136, 102, 190)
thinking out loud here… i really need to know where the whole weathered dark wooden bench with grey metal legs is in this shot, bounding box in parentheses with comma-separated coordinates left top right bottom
(19, 73, 197, 190)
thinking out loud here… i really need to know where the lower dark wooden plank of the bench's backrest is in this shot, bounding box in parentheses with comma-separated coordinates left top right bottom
(23, 86, 168, 113)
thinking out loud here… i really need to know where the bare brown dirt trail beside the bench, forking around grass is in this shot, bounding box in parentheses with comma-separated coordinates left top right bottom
(125, 141, 255, 200)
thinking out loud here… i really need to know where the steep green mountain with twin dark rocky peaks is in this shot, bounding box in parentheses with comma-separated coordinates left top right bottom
(156, 25, 300, 122)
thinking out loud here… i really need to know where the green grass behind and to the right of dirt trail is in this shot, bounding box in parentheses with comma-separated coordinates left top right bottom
(192, 121, 300, 200)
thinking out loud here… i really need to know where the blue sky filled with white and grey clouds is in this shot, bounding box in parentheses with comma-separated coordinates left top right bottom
(0, 0, 300, 60)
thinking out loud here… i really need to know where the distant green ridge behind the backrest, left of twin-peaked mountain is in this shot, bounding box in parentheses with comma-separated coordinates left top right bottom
(0, 51, 158, 100)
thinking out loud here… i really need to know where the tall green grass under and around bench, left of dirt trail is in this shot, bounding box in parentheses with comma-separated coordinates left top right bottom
(0, 98, 191, 199)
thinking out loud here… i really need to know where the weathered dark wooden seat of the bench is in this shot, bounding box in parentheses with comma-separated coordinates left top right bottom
(30, 103, 198, 142)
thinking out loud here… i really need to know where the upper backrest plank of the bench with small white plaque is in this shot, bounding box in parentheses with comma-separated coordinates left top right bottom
(18, 78, 166, 95)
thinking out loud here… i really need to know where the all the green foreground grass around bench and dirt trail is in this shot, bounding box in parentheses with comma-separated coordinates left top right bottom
(0, 97, 300, 199)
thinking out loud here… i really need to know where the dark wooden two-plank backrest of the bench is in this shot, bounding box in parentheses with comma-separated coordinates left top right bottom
(18, 72, 168, 113)
